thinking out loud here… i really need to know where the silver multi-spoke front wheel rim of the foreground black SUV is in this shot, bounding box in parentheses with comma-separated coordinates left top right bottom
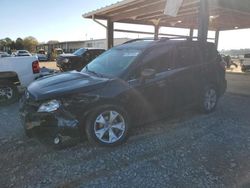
(94, 111, 126, 144)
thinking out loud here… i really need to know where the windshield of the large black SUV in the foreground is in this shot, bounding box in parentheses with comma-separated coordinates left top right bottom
(82, 49, 141, 77)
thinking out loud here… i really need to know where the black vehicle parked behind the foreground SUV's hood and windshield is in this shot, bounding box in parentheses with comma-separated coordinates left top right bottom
(56, 48, 105, 72)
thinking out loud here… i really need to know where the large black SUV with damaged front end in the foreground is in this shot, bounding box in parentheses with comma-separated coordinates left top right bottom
(20, 39, 226, 146)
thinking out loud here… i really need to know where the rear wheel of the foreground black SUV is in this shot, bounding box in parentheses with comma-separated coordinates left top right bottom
(200, 85, 219, 114)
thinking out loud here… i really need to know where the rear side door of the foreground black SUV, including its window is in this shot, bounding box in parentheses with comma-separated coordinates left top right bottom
(171, 44, 200, 109)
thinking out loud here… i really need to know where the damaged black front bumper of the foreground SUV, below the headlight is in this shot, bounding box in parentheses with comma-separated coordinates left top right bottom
(20, 98, 79, 138)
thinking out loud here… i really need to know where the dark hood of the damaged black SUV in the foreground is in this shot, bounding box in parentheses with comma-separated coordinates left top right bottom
(28, 71, 109, 100)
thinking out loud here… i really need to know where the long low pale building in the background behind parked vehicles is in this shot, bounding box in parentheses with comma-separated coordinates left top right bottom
(36, 38, 130, 53)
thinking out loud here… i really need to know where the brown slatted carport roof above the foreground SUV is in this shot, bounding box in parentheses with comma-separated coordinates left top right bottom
(83, 0, 250, 30)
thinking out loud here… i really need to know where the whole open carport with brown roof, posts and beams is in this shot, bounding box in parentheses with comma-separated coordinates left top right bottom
(83, 0, 250, 48)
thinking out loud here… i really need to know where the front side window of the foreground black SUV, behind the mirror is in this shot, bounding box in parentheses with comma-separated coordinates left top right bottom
(143, 46, 173, 73)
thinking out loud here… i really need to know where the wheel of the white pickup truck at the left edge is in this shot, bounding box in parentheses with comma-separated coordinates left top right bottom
(0, 80, 18, 105)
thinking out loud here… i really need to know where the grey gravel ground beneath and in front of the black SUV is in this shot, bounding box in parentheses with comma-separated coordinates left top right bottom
(0, 74, 250, 188)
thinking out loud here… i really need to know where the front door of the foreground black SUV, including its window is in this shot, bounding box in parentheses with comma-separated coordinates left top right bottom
(126, 46, 173, 120)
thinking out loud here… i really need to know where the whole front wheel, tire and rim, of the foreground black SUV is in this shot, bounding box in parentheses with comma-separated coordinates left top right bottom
(85, 105, 130, 147)
